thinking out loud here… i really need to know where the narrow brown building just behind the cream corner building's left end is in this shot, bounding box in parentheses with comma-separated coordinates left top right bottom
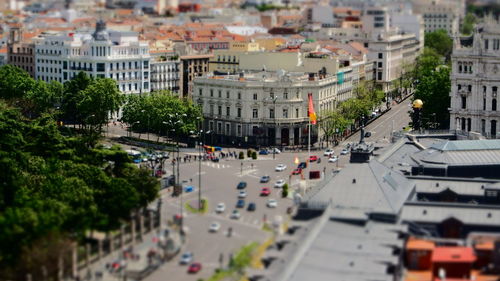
(179, 54, 213, 97)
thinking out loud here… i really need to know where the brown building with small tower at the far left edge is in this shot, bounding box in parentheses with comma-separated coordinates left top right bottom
(6, 26, 35, 77)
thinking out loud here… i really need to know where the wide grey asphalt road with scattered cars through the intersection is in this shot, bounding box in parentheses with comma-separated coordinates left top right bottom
(116, 98, 409, 281)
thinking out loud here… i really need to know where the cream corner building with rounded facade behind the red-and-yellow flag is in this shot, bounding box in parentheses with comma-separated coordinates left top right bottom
(193, 67, 359, 146)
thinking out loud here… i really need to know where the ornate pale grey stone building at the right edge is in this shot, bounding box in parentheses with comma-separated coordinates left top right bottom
(450, 21, 500, 138)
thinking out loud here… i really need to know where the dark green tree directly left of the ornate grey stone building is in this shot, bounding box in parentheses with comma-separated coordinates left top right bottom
(414, 65, 451, 129)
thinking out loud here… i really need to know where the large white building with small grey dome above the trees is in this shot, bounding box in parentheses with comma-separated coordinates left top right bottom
(34, 21, 151, 93)
